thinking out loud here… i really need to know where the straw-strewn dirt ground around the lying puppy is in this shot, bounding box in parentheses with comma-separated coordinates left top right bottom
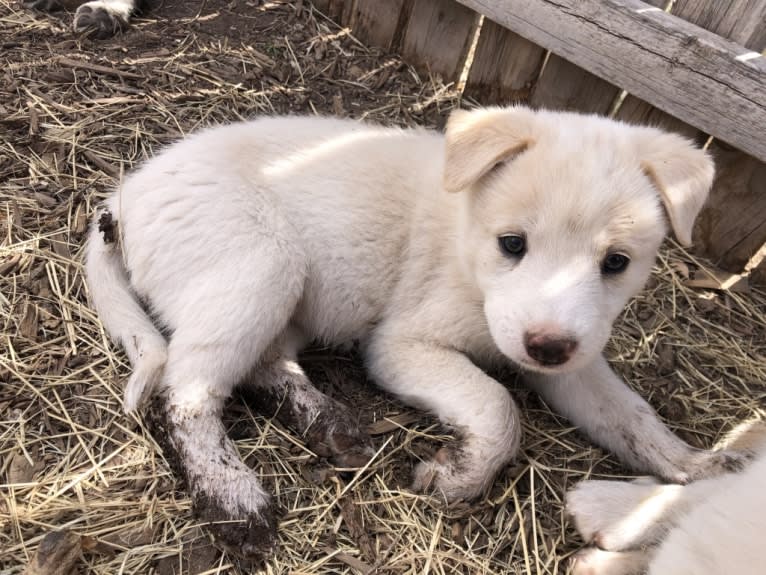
(0, 0, 766, 575)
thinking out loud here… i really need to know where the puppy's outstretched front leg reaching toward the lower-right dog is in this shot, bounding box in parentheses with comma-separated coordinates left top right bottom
(525, 357, 747, 483)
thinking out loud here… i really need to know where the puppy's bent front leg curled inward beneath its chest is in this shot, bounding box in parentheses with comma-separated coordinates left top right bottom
(367, 336, 521, 500)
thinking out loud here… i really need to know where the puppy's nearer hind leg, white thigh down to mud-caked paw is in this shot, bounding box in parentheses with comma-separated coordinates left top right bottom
(159, 239, 305, 560)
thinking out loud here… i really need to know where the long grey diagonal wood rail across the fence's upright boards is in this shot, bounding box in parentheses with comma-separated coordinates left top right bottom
(452, 0, 766, 160)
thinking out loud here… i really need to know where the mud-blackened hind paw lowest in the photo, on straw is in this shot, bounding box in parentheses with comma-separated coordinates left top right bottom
(194, 496, 277, 565)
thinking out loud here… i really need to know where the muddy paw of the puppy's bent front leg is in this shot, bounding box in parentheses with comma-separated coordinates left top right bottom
(412, 447, 492, 501)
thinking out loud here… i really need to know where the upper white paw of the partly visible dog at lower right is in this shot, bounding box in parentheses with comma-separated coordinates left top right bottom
(567, 481, 682, 551)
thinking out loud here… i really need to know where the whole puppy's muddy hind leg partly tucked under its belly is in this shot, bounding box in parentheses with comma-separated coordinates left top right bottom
(247, 329, 374, 467)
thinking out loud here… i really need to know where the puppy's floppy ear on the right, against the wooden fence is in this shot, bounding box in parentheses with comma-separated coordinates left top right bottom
(641, 133, 715, 246)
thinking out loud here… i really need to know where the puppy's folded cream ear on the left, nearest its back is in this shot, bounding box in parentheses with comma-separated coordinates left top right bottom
(444, 107, 535, 192)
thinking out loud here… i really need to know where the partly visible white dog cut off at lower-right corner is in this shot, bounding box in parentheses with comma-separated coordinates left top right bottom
(567, 423, 766, 575)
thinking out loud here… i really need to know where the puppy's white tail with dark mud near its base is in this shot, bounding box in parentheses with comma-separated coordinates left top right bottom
(85, 210, 168, 412)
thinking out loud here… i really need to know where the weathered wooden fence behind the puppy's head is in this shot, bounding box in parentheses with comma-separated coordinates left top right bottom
(314, 0, 766, 280)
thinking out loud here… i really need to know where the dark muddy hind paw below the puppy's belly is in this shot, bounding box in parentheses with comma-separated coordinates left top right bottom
(306, 403, 375, 467)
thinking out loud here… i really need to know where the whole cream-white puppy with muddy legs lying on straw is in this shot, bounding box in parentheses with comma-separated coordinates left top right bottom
(87, 108, 744, 555)
